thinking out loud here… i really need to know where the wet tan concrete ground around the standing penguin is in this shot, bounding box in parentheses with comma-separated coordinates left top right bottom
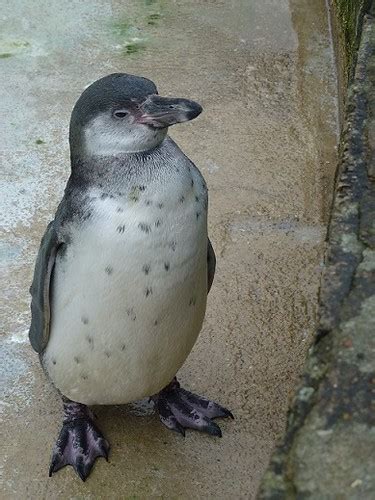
(0, 0, 337, 499)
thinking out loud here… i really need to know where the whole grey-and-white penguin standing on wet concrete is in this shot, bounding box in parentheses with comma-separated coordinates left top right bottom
(29, 73, 233, 480)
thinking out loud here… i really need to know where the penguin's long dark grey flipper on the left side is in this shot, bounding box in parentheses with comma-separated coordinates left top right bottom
(29, 221, 62, 354)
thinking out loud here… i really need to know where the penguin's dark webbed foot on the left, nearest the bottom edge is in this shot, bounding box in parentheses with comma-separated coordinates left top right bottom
(49, 400, 109, 481)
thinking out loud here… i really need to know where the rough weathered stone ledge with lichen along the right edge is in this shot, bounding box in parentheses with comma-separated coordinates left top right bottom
(258, 4, 375, 500)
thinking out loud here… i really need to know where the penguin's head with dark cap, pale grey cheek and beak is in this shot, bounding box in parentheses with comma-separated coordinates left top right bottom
(69, 73, 202, 158)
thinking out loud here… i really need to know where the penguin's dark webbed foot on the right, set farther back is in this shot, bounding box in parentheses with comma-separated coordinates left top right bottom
(152, 378, 234, 437)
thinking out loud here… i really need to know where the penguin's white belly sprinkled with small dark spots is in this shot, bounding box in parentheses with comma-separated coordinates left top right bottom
(42, 182, 207, 404)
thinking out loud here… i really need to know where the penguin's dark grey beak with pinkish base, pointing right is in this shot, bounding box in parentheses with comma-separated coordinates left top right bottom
(137, 95, 202, 128)
